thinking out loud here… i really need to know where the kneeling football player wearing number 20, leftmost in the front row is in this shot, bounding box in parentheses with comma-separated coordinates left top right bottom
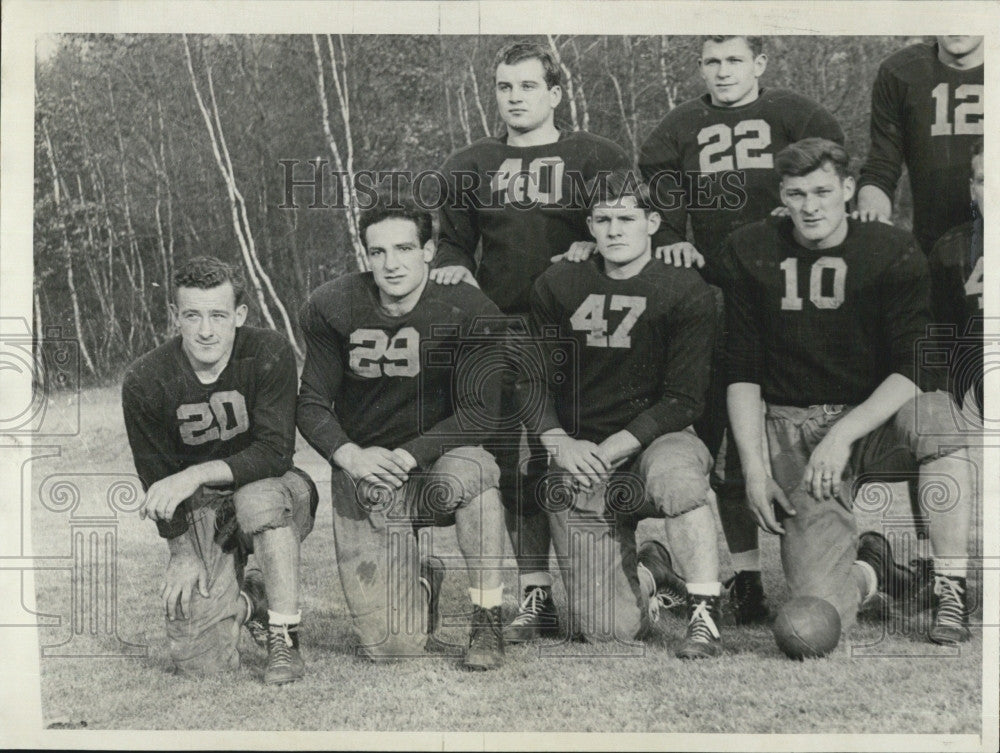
(122, 257, 317, 684)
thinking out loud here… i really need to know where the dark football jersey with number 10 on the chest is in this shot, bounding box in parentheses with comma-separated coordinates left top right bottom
(722, 218, 930, 406)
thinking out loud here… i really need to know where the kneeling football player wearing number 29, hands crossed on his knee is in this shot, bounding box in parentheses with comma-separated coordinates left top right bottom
(298, 196, 505, 669)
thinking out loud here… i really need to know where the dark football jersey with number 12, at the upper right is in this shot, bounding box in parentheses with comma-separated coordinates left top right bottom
(859, 44, 983, 253)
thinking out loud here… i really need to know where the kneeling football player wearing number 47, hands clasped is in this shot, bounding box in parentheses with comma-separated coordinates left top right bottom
(531, 172, 722, 658)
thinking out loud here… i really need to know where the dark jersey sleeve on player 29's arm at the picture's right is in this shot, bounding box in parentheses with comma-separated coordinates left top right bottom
(401, 297, 505, 468)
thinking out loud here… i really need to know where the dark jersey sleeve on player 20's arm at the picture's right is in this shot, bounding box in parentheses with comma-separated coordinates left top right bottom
(223, 338, 296, 488)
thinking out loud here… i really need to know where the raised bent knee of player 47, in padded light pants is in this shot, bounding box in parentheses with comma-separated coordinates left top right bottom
(639, 431, 711, 518)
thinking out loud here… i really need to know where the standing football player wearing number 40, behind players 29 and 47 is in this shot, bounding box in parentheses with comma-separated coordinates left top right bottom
(431, 42, 630, 643)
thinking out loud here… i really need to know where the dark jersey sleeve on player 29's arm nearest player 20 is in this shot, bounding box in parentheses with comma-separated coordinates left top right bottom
(295, 299, 351, 463)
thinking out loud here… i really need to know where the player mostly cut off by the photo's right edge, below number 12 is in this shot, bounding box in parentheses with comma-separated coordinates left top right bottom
(928, 139, 985, 428)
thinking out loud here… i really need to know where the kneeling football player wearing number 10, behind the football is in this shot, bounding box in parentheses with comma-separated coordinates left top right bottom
(724, 138, 973, 643)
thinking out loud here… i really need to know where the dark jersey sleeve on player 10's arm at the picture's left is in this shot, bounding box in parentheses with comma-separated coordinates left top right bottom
(718, 239, 764, 384)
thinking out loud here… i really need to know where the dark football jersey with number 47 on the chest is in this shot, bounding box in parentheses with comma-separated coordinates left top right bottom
(531, 256, 717, 447)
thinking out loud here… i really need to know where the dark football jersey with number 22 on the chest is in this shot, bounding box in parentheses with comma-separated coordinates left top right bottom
(639, 89, 844, 279)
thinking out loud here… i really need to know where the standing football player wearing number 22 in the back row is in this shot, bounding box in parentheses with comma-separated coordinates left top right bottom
(564, 36, 844, 624)
